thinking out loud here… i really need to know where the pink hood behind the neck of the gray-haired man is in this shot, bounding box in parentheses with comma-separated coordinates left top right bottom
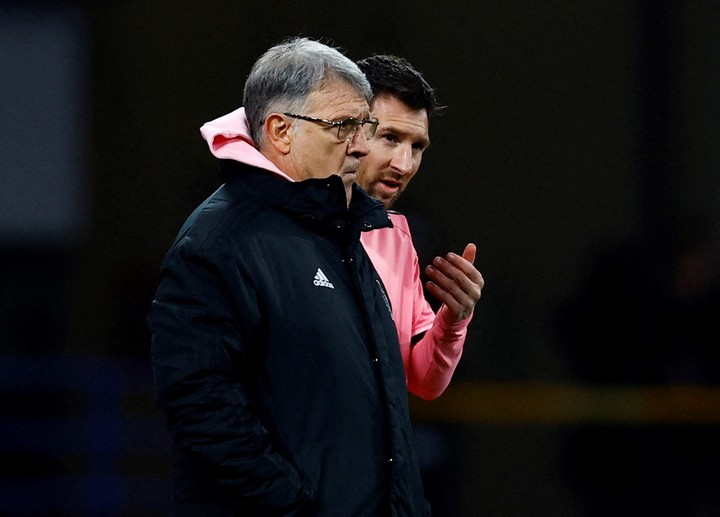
(200, 108, 294, 181)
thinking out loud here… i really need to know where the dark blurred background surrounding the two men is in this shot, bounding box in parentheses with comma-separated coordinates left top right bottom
(0, 0, 720, 517)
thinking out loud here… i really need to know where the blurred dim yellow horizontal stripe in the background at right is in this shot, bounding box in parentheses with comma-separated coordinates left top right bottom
(410, 382, 720, 425)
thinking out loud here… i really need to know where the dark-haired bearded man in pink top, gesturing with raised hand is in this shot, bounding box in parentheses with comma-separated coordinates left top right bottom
(356, 55, 484, 399)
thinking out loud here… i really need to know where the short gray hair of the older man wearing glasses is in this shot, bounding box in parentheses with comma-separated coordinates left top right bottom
(243, 37, 372, 147)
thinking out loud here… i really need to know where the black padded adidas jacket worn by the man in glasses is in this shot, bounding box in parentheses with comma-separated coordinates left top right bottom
(148, 161, 429, 517)
